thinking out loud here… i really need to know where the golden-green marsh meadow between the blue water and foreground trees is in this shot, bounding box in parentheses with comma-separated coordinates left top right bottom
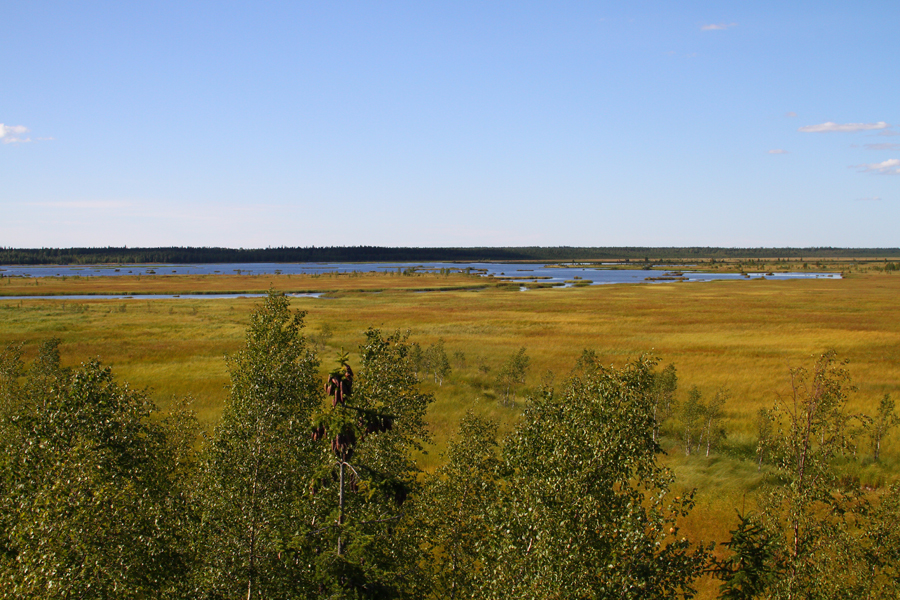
(0, 267, 900, 592)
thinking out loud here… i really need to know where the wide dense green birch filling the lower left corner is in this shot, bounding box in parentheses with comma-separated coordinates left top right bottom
(0, 340, 196, 599)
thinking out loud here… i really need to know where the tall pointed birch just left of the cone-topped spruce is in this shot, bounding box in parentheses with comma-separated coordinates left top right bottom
(195, 292, 321, 600)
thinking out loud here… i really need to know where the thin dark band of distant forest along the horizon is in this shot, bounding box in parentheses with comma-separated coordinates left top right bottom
(0, 246, 900, 265)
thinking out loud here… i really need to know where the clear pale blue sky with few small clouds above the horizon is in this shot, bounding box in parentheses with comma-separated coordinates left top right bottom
(0, 0, 900, 248)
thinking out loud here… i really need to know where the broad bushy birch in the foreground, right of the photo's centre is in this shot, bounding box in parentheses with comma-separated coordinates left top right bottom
(483, 358, 707, 599)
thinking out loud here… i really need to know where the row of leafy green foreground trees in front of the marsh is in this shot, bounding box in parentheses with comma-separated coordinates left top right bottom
(0, 294, 900, 599)
